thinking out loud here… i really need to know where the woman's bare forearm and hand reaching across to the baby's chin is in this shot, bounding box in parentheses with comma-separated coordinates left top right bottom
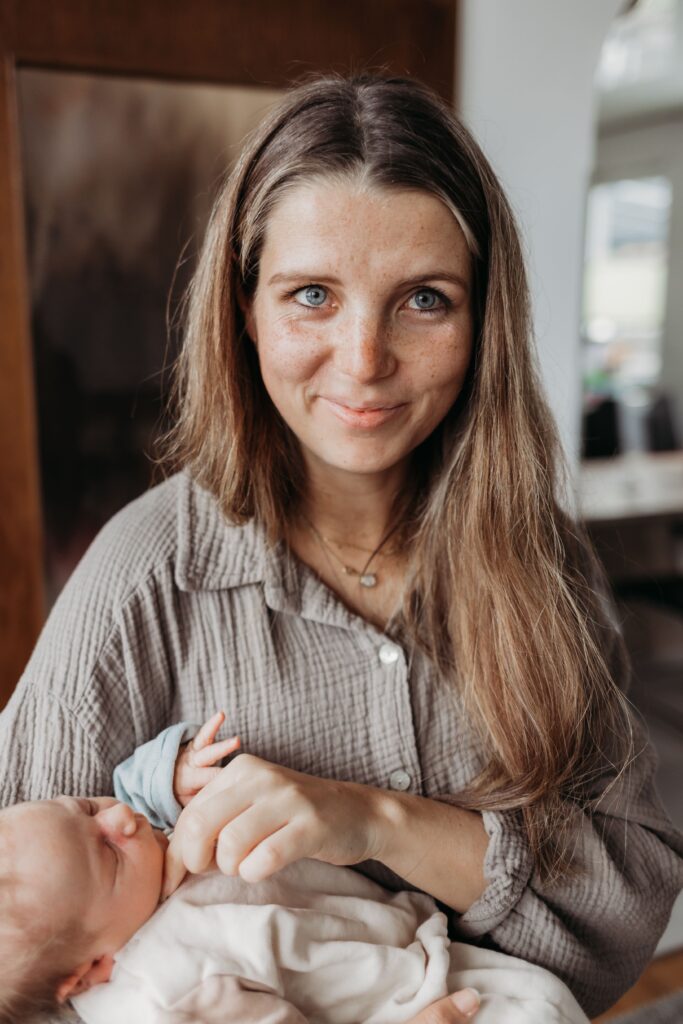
(160, 754, 487, 912)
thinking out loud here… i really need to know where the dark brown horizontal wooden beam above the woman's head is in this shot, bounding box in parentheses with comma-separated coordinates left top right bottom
(5, 0, 455, 98)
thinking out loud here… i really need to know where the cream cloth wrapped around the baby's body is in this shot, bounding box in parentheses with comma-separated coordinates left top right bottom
(74, 860, 588, 1024)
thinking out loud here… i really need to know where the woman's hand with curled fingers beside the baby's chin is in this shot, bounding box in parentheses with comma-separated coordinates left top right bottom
(163, 754, 381, 896)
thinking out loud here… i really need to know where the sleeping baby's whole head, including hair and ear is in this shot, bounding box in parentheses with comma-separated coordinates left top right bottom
(0, 797, 166, 1024)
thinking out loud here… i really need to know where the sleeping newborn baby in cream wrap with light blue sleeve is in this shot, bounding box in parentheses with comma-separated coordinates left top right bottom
(0, 713, 587, 1024)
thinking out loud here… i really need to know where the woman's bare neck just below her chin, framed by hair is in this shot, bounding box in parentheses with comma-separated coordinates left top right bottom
(296, 454, 407, 549)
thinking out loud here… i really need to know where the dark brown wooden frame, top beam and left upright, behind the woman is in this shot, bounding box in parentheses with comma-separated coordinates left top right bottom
(0, 0, 456, 708)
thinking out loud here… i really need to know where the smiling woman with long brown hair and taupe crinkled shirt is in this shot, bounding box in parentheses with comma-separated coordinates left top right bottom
(0, 77, 682, 1014)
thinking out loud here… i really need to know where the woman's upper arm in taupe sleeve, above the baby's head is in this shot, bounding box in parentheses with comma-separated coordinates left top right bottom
(0, 488, 180, 806)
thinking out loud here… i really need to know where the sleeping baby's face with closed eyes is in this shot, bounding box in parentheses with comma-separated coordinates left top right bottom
(3, 797, 167, 956)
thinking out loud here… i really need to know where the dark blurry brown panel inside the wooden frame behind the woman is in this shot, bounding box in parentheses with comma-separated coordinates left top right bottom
(18, 77, 281, 606)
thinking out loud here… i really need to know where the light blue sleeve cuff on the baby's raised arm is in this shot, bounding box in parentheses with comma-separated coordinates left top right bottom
(114, 722, 200, 831)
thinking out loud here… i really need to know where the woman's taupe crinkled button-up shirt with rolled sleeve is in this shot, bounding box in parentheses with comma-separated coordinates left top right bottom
(0, 474, 683, 1015)
